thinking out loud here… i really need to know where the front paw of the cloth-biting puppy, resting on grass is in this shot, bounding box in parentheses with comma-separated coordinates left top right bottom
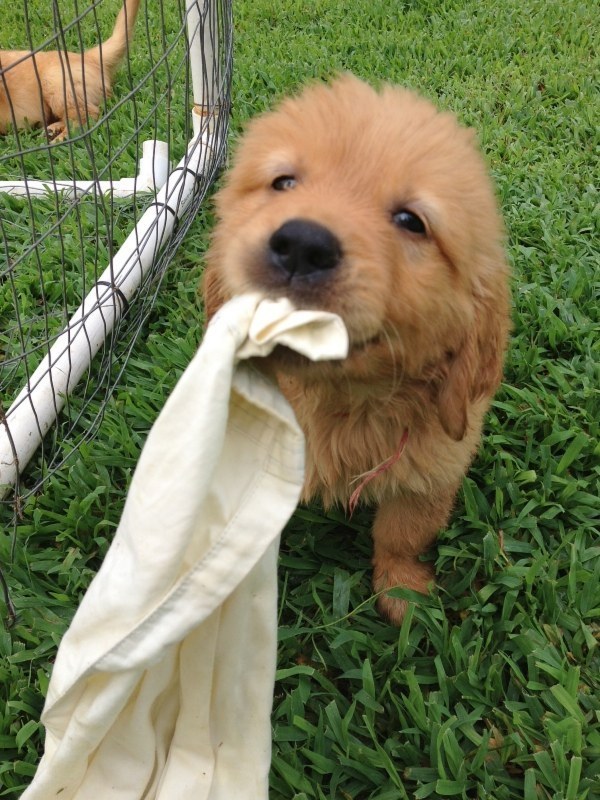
(373, 554, 434, 625)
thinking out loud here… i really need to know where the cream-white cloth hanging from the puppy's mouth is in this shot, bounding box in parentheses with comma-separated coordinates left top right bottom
(22, 295, 348, 800)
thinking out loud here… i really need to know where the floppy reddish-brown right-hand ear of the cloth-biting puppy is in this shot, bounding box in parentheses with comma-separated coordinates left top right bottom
(437, 287, 509, 441)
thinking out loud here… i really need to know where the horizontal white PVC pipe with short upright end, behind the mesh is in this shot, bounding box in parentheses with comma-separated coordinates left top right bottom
(0, 139, 170, 197)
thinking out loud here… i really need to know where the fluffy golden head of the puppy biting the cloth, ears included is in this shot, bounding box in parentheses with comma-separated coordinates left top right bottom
(205, 76, 507, 438)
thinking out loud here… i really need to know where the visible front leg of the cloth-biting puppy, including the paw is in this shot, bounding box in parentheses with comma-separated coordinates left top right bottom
(373, 489, 456, 625)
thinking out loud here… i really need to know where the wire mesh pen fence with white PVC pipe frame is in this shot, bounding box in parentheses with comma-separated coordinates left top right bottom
(0, 0, 232, 511)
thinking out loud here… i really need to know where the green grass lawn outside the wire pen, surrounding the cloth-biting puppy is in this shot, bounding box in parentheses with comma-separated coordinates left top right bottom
(0, 0, 600, 800)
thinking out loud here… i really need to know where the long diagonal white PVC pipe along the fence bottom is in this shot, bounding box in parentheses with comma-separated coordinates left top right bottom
(0, 124, 223, 498)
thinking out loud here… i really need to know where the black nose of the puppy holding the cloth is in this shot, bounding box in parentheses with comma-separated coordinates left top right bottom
(269, 219, 342, 278)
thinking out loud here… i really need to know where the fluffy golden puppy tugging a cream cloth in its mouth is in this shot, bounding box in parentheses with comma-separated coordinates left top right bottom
(205, 76, 509, 623)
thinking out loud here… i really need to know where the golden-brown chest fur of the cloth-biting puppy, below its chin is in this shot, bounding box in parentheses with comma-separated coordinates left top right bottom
(279, 377, 476, 506)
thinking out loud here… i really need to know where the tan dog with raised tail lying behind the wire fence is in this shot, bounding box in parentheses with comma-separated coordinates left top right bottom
(0, 0, 140, 141)
